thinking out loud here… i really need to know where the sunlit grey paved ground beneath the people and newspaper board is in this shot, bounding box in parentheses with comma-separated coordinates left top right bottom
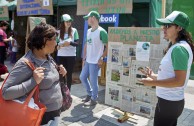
(0, 62, 194, 126)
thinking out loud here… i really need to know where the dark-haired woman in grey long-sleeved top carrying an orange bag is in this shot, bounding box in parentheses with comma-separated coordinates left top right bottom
(2, 22, 67, 126)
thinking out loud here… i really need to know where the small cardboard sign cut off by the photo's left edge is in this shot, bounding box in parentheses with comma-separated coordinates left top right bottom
(0, 6, 9, 21)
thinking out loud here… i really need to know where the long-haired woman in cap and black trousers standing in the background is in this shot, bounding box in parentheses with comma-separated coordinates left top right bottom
(57, 14, 79, 90)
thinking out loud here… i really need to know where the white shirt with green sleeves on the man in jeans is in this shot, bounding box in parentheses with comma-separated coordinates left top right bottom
(86, 26, 108, 64)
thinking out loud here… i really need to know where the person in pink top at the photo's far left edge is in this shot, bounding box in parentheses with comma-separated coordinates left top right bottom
(0, 21, 12, 65)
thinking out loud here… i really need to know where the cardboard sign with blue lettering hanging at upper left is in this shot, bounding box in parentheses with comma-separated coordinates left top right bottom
(17, 0, 53, 16)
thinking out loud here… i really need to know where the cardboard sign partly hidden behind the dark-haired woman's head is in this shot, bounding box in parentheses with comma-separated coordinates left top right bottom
(25, 17, 46, 52)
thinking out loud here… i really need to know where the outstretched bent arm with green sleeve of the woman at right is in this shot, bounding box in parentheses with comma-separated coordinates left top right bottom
(141, 46, 189, 88)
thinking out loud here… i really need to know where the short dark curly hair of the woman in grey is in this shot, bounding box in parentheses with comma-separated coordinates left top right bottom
(27, 22, 57, 51)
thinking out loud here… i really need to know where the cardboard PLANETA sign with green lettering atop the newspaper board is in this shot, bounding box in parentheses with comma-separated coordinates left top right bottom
(108, 27, 160, 45)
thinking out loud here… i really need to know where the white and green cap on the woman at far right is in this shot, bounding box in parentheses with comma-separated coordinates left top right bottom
(156, 11, 189, 29)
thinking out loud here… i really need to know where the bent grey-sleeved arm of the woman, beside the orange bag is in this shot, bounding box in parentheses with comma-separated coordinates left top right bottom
(2, 61, 36, 100)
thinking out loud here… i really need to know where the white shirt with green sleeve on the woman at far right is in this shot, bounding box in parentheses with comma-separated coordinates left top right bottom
(156, 41, 193, 101)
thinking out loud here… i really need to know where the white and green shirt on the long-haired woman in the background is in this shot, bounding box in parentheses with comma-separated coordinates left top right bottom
(57, 28, 79, 56)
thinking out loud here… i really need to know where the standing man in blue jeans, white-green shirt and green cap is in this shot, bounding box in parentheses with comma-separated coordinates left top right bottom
(80, 11, 108, 106)
